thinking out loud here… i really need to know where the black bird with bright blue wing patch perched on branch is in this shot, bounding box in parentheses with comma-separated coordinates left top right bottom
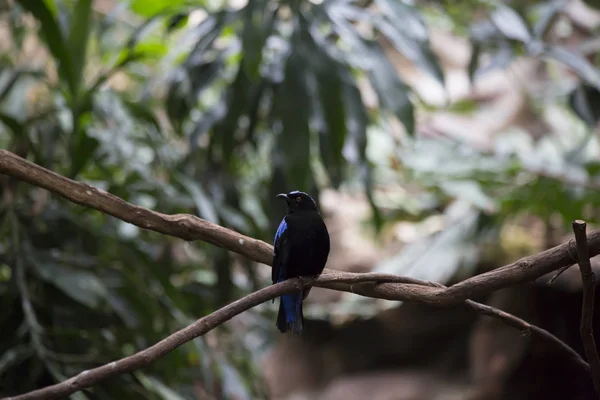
(271, 190, 330, 335)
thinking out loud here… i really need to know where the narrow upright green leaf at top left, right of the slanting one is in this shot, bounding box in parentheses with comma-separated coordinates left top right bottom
(69, 0, 93, 99)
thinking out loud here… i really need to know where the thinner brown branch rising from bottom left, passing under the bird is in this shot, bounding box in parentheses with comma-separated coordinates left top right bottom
(0, 272, 589, 400)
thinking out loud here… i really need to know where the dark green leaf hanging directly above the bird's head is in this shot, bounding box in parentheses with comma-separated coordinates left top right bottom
(273, 52, 311, 190)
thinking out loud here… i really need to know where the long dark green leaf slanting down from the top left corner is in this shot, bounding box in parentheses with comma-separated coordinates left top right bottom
(17, 0, 76, 93)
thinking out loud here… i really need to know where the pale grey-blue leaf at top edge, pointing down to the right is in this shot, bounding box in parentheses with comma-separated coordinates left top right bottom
(375, 0, 444, 85)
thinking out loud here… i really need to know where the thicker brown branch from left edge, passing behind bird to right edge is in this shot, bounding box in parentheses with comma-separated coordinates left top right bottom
(0, 150, 600, 306)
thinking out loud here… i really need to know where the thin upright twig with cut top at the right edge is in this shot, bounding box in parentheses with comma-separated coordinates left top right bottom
(572, 220, 600, 397)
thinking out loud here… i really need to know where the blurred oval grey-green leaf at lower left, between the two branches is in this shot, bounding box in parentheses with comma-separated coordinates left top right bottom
(32, 260, 108, 309)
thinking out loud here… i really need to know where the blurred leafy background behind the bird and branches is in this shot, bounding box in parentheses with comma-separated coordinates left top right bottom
(0, 0, 600, 400)
